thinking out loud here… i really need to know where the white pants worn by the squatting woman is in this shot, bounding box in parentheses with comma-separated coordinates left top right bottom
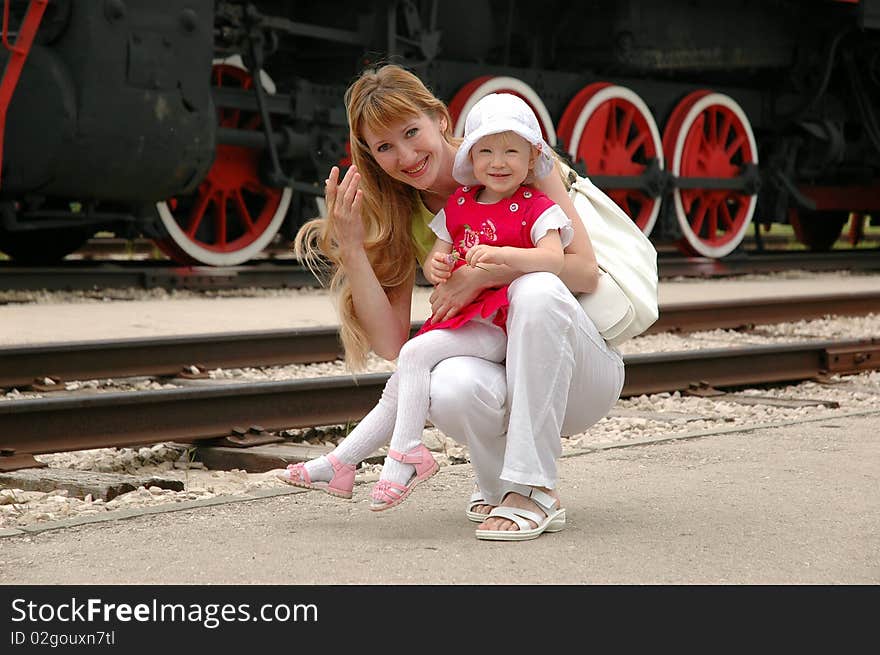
(428, 273, 624, 505)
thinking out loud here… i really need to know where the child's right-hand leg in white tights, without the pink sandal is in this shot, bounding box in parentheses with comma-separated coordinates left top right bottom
(381, 321, 507, 485)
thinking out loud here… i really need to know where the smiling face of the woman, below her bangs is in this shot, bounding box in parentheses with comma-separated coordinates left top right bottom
(363, 114, 452, 189)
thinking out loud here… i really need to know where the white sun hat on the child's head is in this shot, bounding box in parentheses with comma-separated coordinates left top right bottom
(452, 93, 553, 184)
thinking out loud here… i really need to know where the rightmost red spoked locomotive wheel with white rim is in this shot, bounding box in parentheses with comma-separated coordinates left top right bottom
(663, 90, 758, 258)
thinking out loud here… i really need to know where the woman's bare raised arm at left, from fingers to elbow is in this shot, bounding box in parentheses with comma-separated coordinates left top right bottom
(325, 166, 415, 359)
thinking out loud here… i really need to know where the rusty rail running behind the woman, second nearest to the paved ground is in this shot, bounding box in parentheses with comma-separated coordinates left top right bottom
(0, 291, 880, 387)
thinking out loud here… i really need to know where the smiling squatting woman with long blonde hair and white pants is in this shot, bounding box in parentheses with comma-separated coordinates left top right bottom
(285, 65, 623, 540)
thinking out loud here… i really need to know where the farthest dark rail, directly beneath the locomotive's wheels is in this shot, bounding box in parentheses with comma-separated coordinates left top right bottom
(0, 250, 880, 291)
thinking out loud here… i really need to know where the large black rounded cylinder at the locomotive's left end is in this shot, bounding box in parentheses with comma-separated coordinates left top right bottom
(0, 0, 216, 201)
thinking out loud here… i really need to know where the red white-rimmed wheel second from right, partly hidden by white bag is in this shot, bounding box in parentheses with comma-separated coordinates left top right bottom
(558, 82, 663, 234)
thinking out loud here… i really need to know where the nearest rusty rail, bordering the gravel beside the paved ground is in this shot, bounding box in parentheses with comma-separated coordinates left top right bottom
(0, 339, 880, 470)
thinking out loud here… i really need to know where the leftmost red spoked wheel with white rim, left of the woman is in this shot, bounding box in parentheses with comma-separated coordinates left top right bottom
(156, 58, 293, 266)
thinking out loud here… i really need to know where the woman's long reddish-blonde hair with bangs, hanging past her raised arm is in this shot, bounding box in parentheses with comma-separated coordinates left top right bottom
(294, 64, 455, 369)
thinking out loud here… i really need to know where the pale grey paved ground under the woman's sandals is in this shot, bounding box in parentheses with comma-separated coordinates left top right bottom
(0, 409, 880, 585)
